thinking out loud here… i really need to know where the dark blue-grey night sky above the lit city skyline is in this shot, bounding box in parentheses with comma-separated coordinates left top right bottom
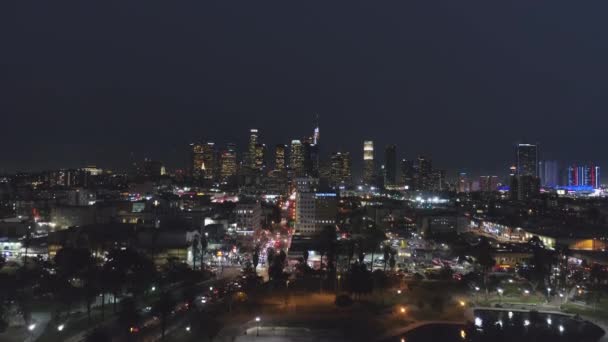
(0, 0, 608, 179)
